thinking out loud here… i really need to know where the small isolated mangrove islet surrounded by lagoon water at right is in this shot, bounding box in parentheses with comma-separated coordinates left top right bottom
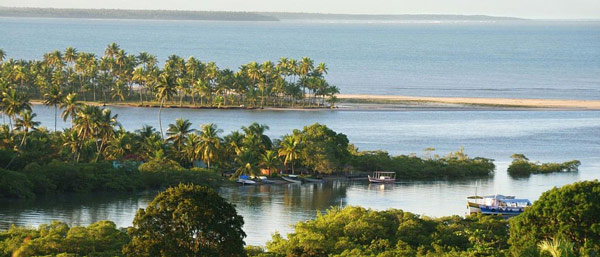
(507, 154, 581, 176)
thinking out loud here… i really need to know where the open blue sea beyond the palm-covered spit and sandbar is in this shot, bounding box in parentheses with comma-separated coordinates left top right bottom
(0, 18, 600, 99)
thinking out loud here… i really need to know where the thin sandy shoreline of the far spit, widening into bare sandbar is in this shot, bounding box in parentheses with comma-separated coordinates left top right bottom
(31, 94, 600, 111)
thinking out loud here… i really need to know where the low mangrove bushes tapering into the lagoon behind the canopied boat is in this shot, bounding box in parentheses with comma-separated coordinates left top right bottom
(350, 148, 496, 179)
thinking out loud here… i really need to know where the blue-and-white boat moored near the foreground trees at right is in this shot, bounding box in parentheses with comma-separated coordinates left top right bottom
(467, 195, 531, 217)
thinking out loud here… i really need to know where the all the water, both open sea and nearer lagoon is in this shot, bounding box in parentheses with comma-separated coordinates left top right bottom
(0, 18, 600, 244)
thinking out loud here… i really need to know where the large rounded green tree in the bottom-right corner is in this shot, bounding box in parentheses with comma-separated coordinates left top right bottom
(509, 180, 600, 256)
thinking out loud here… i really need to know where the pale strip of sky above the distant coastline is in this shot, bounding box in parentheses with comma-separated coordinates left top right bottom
(0, 0, 600, 19)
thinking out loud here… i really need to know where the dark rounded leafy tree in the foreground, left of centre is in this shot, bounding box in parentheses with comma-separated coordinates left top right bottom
(123, 184, 246, 256)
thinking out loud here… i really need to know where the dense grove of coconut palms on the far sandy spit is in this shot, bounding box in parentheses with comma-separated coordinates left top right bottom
(0, 43, 339, 108)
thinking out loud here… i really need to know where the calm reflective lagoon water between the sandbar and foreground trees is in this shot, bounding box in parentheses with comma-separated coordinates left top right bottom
(0, 106, 600, 244)
